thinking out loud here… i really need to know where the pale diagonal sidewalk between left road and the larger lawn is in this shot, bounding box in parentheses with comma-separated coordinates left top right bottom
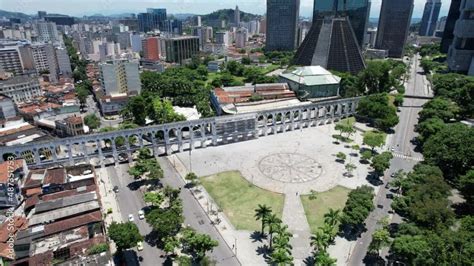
(168, 155, 267, 266)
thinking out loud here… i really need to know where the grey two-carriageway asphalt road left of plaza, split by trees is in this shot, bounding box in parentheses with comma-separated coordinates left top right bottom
(107, 157, 240, 266)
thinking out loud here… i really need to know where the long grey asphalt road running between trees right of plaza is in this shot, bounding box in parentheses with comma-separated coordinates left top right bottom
(346, 55, 431, 265)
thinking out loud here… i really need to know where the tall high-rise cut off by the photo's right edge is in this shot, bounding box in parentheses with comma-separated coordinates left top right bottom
(448, 0, 474, 76)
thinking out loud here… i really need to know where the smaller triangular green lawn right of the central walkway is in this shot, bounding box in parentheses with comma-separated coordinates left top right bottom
(301, 186, 351, 233)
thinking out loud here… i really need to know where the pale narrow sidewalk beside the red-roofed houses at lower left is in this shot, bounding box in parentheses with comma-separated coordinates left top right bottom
(96, 167, 122, 253)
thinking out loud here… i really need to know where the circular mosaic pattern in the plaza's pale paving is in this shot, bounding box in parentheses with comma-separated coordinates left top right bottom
(258, 153, 323, 183)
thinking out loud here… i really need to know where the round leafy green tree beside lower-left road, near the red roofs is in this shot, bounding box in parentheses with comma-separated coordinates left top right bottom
(108, 222, 143, 251)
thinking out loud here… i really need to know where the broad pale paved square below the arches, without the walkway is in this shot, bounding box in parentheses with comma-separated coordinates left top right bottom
(177, 125, 368, 194)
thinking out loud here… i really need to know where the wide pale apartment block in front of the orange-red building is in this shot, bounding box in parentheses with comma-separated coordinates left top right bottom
(99, 60, 141, 95)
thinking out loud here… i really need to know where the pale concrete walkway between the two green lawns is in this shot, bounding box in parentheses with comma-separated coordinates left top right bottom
(283, 187, 311, 265)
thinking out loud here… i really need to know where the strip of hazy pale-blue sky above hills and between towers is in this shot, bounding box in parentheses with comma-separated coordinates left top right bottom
(0, 0, 451, 17)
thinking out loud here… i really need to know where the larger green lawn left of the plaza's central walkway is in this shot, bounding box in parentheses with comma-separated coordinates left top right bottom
(201, 171, 285, 231)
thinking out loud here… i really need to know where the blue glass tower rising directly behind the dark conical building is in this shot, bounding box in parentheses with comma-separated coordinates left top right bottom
(313, 0, 372, 47)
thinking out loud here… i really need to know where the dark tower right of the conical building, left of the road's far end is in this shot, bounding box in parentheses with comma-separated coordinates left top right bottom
(375, 0, 414, 58)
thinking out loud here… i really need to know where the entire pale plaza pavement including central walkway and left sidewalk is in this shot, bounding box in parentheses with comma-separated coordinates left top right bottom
(168, 124, 378, 265)
